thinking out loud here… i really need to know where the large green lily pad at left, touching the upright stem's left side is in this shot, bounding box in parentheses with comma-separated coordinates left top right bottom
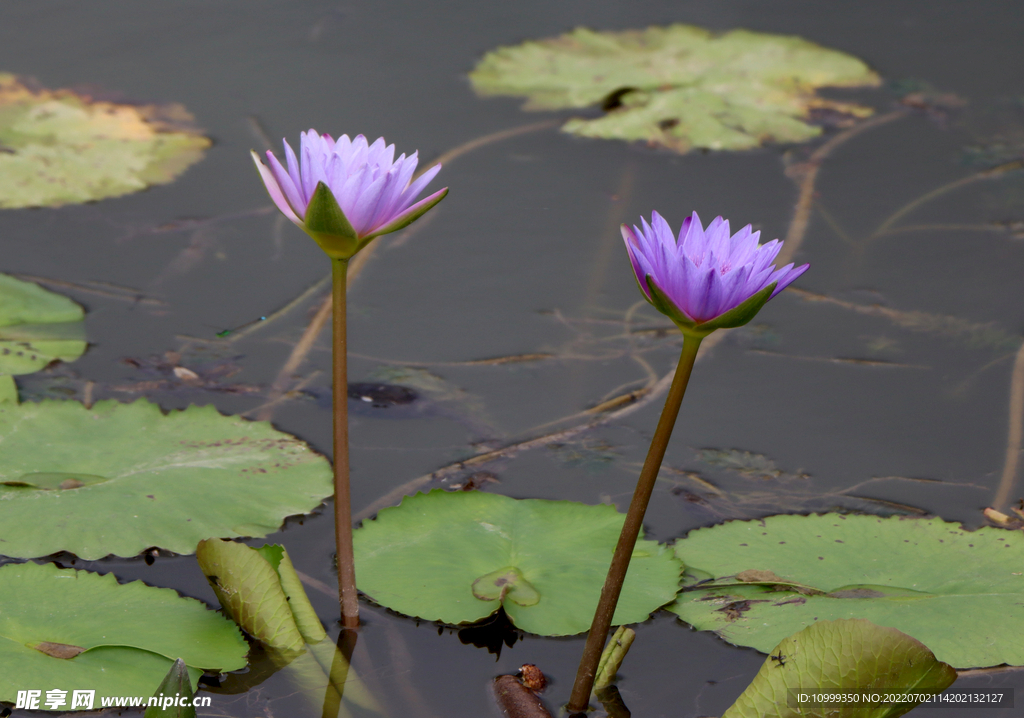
(0, 399, 334, 559)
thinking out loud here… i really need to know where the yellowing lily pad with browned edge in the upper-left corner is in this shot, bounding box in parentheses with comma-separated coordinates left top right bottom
(0, 74, 210, 208)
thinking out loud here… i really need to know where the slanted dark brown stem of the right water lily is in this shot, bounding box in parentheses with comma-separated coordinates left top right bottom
(567, 334, 702, 715)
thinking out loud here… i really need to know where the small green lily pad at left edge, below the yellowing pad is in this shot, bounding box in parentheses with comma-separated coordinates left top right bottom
(0, 274, 86, 387)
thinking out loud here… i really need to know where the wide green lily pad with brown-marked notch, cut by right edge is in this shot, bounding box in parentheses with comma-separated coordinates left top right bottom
(669, 514, 1024, 668)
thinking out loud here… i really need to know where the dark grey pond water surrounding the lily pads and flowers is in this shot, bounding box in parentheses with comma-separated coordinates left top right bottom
(0, 0, 1024, 718)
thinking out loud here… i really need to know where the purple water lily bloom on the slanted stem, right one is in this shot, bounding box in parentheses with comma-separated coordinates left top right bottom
(622, 212, 810, 337)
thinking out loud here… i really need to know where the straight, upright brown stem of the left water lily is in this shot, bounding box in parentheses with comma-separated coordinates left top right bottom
(331, 258, 359, 628)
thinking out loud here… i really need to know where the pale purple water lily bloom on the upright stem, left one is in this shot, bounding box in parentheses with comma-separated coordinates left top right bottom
(252, 129, 447, 259)
